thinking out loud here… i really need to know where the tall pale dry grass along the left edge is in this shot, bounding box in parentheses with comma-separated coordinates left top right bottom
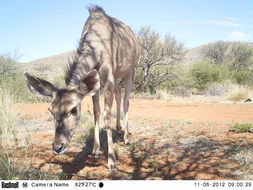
(0, 88, 28, 179)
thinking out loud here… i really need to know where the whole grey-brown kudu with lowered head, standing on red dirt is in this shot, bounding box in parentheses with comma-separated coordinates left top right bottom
(25, 6, 140, 170)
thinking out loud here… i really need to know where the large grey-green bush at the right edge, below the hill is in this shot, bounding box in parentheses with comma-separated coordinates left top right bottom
(201, 41, 253, 86)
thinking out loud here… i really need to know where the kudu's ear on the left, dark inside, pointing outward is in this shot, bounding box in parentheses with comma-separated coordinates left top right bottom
(24, 73, 56, 97)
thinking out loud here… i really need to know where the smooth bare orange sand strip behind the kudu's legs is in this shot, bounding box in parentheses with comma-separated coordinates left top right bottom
(20, 98, 253, 122)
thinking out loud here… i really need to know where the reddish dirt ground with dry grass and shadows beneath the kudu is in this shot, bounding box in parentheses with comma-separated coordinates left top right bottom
(18, 98, 253, 179)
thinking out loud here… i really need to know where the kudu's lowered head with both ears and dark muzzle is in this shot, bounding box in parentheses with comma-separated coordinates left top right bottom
(25, 70, 100, 154)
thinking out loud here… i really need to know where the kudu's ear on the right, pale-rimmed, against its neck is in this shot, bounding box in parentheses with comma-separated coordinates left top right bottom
(78, 69, 100, 96)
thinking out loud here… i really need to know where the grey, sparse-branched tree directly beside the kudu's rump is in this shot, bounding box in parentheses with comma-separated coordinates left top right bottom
(134, 27, 185, 95)
